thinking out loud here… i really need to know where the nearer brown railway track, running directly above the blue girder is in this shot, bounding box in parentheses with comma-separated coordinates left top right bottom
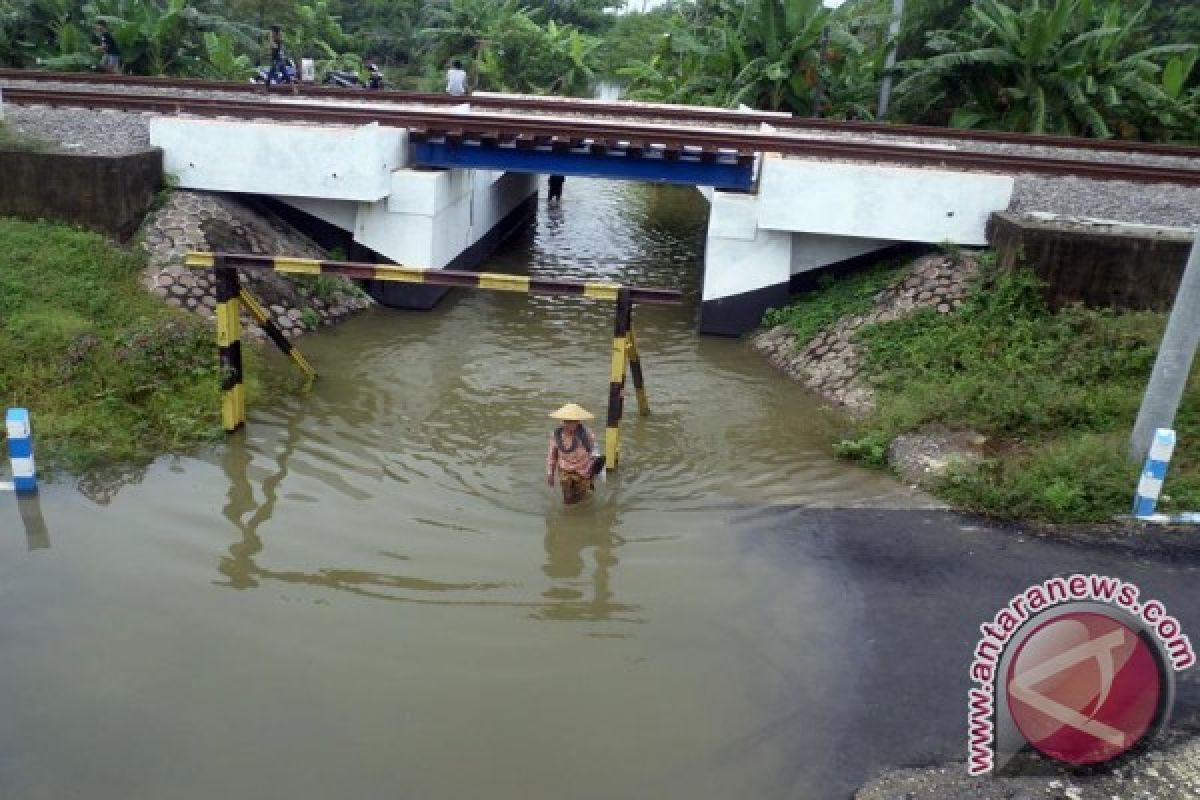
(4, 79, 1200, 186)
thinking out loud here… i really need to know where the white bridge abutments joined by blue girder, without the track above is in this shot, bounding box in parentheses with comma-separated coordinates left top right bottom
(150, 115, 1014, 336)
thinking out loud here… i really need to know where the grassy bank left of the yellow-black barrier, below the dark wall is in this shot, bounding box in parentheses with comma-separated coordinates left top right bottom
(0, 218, 288, 471)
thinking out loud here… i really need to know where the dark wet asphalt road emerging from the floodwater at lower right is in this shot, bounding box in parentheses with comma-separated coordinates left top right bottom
(730, 509, 1200, 798)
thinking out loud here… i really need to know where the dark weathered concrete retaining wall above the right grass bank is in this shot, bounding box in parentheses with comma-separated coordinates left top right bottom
(988, 212, 1192, 311)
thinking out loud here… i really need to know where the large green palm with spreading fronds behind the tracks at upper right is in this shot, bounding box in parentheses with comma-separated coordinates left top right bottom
(896, 0, 1195, 138)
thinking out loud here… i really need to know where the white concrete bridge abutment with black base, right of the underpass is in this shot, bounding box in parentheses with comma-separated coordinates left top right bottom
(700, 157, 1014, 336)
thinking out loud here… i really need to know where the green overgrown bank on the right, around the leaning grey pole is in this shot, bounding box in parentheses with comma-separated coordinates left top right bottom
(772, 257, 1200, 522)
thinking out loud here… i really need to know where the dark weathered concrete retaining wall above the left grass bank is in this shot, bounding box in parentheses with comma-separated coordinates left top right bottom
(0, 150, 162, 239)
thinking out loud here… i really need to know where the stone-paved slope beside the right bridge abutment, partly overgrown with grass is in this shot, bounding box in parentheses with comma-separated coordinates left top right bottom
(754, 253, 979, 414)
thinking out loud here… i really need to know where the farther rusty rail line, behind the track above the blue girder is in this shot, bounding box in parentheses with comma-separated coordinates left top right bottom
(0, 70, 1200, 158)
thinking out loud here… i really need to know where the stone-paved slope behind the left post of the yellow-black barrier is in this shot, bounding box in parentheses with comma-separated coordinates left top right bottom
(142, 191, 372, 338)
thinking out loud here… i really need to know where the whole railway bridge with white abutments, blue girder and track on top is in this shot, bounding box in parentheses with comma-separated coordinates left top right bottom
(7, 71, 1200, 335)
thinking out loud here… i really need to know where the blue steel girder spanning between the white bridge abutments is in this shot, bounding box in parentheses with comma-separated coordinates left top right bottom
(409, 140, 754, 192)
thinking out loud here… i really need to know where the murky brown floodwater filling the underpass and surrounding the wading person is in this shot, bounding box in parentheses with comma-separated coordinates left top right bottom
(0, 179, 922, 800)
